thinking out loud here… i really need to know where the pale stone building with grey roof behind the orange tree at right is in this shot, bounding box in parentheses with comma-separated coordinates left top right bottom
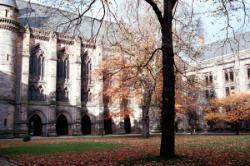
(187, 32, 250, 128)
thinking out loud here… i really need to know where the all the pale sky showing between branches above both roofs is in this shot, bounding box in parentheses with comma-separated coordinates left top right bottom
(23, 0, 250, 43)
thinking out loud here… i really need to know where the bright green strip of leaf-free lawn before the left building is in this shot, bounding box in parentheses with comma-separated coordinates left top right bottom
(0, 142, 124, 155)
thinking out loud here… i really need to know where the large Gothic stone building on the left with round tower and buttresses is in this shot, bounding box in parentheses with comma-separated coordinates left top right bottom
(0, 0, 145, 138)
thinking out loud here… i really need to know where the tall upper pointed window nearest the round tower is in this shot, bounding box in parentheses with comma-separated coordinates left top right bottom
(29, 45, 44, 79)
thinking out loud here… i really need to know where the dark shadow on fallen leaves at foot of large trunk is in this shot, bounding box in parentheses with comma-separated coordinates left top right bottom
(118, 154, 191, 166)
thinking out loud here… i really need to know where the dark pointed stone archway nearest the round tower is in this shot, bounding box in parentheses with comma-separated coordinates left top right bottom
(28, 111, 47, 136)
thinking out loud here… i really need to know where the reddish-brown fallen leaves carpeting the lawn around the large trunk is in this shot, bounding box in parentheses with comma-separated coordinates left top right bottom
(2, 136, 250, 166)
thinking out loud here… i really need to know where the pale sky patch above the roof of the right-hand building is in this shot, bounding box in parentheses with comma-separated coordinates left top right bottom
(189, 0, 250, 43)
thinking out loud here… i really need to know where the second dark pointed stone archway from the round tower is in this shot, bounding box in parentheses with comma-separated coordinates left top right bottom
(56, 111, 72, 136)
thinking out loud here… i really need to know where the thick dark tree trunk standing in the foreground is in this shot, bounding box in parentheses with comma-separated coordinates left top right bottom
(160, 0, 175, 157)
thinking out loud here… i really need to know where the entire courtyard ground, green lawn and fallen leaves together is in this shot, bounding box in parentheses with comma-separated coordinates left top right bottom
(0, 135, 250, 166)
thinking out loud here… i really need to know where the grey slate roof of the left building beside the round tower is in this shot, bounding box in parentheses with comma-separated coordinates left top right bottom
(17, 0, 114, 39)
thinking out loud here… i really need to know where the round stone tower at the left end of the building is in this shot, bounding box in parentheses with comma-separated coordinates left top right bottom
(0, 0, 20, 137)
